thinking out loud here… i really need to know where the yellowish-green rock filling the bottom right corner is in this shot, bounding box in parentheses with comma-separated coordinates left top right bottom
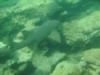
(82, 48, 100, 75)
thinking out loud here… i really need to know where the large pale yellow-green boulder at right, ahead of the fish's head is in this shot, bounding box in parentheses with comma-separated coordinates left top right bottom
(63, 10, 100, 47)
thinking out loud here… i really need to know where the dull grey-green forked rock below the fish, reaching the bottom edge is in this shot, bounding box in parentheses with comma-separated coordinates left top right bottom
(32, 51, 65, 75)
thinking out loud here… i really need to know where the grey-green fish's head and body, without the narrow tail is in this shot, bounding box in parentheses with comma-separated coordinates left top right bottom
(15, 20, 59, 49)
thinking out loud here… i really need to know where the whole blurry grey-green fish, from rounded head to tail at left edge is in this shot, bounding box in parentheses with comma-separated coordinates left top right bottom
(0, 20, 60, 56)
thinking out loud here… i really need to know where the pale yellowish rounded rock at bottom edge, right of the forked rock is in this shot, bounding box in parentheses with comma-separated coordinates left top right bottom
(50, 61, 82, 75)
